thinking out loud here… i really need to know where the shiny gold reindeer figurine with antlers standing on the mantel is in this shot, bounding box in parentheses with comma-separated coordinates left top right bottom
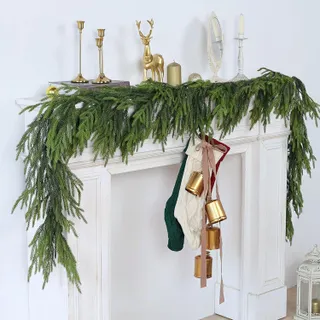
(136, 19, 164, 82)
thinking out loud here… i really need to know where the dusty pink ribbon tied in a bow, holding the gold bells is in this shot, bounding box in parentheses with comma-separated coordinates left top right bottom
(197, 137, 224, 304)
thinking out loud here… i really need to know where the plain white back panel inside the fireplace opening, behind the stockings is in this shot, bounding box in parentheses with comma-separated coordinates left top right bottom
(111, 165, 214, 320)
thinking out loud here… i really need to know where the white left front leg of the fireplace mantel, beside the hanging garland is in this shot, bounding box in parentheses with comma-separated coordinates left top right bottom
(68, 166, 111, 320)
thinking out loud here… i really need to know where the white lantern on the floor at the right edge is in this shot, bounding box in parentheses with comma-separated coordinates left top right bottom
(294, 245, 320, 320)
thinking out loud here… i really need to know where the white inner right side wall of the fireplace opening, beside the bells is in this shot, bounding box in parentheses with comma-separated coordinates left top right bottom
(215, 154, 243, 319)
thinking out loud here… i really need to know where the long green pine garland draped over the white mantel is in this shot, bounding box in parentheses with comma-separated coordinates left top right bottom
(13, 69, 320, 290)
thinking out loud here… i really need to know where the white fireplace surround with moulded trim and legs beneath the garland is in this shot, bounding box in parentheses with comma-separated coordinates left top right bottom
(16, 99, 289, 320)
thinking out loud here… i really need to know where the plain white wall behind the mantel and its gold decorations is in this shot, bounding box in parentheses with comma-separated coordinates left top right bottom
(0, 0, 320, 320)
